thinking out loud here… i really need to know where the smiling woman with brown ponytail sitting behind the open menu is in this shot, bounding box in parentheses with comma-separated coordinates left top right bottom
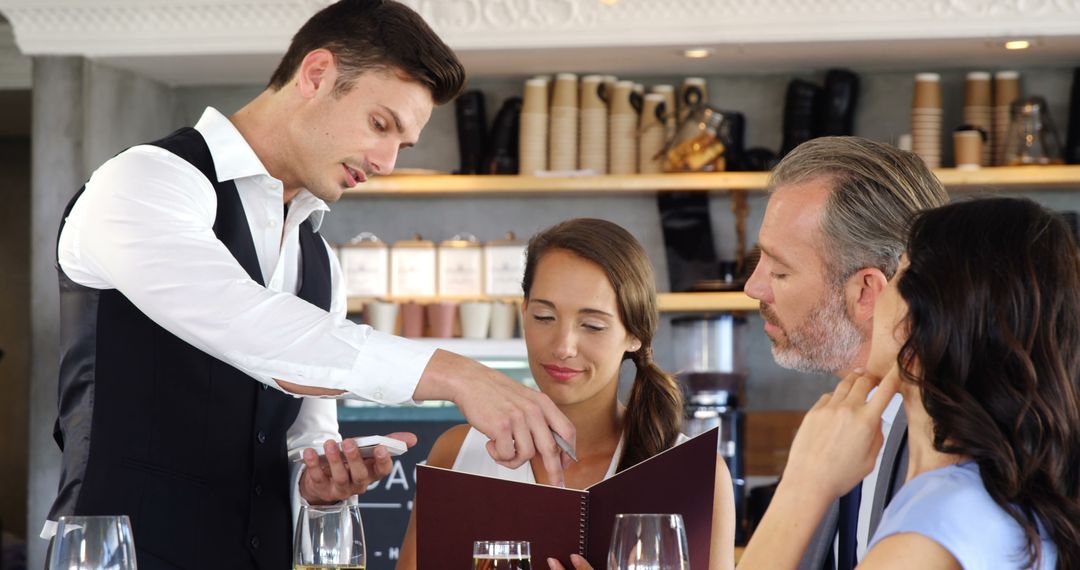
(397, 218, 734, 569)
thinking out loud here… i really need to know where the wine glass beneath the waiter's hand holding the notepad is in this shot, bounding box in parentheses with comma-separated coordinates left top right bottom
(293, 505, 367, 570)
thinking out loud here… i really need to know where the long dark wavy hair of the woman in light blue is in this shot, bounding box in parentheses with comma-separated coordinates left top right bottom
(897, 198, 1080, 568)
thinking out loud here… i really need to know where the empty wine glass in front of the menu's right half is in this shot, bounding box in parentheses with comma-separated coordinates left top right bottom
(608, 514, 690, 570)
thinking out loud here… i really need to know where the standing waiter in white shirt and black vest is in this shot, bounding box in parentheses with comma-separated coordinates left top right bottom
(42, 0, 575, 570)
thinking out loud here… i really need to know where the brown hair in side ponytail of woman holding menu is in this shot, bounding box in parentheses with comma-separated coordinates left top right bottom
(522, 218, 683, 471)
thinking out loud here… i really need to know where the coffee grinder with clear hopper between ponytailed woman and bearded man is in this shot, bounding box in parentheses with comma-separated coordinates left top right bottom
(672, 313, 746, 544)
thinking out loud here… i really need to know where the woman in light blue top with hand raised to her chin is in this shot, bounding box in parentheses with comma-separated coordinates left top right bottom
(740, 198, 1080, 570)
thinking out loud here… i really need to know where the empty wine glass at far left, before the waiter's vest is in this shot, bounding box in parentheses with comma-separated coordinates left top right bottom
(49, 515, 138, 570)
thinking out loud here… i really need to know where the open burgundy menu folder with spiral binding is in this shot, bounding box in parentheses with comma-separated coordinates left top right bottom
(416, 429, 717, 570)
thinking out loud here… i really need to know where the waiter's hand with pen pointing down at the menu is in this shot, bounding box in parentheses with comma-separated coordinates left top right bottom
(413, 350, 577, 486)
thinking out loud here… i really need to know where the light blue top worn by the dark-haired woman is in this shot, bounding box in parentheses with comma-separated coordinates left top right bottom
(869, 461, 1057, 570)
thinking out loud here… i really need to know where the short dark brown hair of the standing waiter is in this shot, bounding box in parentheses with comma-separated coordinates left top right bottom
(268, 0, 465, 105)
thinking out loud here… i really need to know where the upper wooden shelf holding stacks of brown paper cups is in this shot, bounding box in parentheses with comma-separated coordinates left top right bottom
(345, 165, 1080, 196)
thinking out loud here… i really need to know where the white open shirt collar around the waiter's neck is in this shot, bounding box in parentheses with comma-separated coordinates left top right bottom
(195, 107, 330, 231)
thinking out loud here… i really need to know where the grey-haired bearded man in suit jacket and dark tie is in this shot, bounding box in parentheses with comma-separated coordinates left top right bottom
(745, 137, 948, 570)
